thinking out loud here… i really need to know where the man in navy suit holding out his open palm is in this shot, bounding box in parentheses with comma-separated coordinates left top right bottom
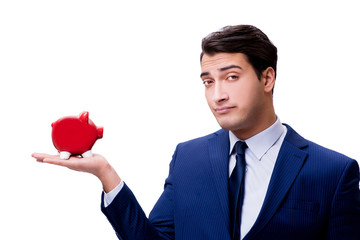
(33, 25, 360, 240)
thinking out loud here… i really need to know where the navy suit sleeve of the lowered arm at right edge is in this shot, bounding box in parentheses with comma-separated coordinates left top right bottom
(328, 160, 360, 240)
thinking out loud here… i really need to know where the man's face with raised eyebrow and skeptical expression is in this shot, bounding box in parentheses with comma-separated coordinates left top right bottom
(201, 53, 276, 140)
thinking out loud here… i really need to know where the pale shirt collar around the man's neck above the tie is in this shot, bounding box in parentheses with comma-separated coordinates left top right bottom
(229, 118, 284, 160)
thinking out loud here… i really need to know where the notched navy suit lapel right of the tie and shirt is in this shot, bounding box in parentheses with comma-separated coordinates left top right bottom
(244, 125, 307, 240)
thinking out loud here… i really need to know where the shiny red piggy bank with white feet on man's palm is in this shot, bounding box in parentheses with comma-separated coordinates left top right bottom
(51, 112, 104, 159)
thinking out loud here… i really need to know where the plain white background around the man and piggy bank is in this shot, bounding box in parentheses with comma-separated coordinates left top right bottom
(0, 0, 360, 240)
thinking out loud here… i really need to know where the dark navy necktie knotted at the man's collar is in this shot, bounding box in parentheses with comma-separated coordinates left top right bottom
(229, 141, 247, 240)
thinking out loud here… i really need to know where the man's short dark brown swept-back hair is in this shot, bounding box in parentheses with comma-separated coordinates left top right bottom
(200, 25, 277, 79)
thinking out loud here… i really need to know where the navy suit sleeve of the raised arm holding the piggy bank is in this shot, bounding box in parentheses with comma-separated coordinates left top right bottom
(101, 148, 176, 240)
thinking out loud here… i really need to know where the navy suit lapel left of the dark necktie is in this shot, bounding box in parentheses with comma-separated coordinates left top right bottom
(209, 130, 230, 232)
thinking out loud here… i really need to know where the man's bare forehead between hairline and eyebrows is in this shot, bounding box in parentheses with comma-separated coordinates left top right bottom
(201, 53, 249, 72)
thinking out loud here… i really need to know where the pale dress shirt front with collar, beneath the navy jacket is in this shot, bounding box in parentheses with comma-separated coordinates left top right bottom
(229, 118, 287, 239)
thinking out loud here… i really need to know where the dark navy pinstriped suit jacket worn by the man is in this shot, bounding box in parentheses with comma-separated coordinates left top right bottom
(102, 126, 360, 240)
